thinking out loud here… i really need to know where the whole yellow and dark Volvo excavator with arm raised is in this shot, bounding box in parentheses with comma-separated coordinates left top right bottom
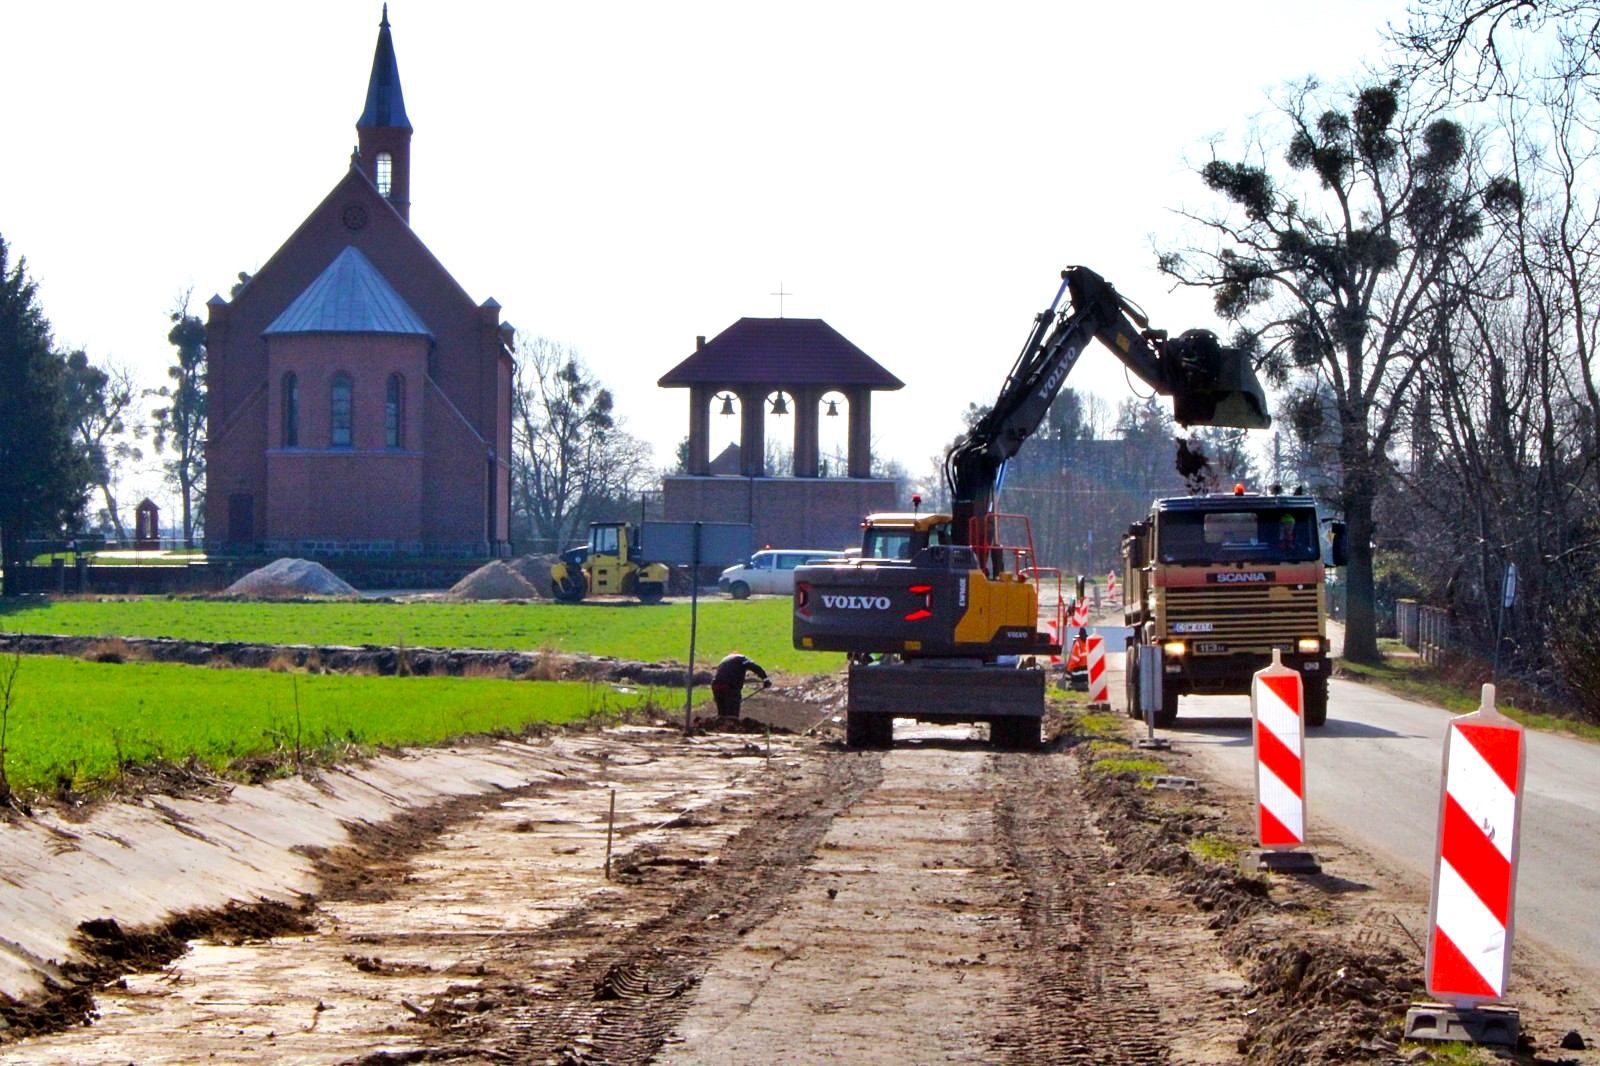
(794, 266, 1272, 749)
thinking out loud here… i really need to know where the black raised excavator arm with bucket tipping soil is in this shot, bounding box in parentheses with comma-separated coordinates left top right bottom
(944, 266, 1272, 543)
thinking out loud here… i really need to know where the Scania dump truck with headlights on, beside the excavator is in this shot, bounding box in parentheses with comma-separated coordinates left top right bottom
(1122, 485, 1346, 727)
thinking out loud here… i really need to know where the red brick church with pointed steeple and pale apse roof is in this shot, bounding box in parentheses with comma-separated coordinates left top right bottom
(205, 5, 514, 557)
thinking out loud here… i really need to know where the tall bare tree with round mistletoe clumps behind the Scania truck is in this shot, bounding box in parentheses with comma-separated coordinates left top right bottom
(1160, 82, 1517, 661)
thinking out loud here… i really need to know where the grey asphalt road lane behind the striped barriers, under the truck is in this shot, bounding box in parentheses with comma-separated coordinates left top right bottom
(1109, 655, 1600, 980)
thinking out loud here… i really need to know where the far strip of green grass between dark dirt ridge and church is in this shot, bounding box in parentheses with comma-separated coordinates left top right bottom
(0, 597, 845, 674)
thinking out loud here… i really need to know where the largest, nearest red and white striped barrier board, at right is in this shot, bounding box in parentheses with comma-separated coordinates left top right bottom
(1427, 685, 1526, 1007)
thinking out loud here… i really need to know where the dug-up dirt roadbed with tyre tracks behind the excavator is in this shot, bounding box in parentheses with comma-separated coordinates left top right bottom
(0, 701, 1600, 1066)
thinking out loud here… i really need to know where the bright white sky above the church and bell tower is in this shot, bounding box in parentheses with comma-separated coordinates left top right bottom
(0, 0, 1405, 512)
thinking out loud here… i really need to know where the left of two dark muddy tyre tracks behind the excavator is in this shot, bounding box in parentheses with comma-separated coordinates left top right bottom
(376, 754, 882, 1066)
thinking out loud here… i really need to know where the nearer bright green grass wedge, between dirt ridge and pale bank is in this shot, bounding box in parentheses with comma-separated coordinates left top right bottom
(0, 656, 683, 791)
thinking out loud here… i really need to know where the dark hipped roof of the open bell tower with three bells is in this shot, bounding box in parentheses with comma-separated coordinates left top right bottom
(656, 319, 906, 389)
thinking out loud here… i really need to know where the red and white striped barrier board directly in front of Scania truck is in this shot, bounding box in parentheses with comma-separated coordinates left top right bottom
(1250, 648, 1306, 852)
